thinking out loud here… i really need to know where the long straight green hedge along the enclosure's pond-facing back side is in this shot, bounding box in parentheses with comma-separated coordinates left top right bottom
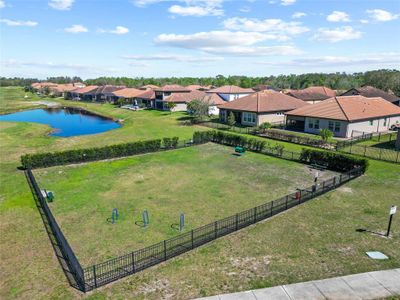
(21, 137, 178, 169)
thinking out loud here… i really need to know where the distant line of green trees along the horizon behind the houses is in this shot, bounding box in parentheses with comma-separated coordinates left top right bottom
(0, 70, 400, 95)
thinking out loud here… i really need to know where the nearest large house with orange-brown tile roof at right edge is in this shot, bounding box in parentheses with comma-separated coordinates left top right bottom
(286, 96, 400, 138)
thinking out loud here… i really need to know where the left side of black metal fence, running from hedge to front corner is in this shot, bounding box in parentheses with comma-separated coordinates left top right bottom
(25, 170, 85, 291)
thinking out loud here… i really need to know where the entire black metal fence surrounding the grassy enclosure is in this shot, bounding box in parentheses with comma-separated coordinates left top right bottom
(26, 141, 363, 292)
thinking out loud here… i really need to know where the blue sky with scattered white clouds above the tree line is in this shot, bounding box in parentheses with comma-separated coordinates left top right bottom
(0, 0, 400, 79)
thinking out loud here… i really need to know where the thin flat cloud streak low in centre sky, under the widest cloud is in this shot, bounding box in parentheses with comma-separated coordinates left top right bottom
(123, 53, 223, 63)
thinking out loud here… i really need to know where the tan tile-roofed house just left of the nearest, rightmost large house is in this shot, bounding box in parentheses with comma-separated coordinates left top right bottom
(219, 90, 309, 126)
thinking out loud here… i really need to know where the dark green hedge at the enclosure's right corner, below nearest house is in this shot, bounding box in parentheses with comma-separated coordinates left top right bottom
(300, 149, 369, 172)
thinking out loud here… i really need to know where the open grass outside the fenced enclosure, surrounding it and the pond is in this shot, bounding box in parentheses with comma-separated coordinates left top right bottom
(0, 88, 400, 299)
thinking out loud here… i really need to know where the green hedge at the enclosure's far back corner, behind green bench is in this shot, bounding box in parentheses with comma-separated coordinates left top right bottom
(193, 130, 267, 152)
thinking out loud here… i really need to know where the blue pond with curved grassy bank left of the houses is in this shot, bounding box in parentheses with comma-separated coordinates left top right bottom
(0, 107, 121, 137)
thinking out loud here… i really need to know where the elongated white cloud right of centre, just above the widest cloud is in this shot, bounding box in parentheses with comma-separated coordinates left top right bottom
(223, 18, 309, 40)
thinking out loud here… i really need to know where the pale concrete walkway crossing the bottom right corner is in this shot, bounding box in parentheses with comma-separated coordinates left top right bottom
(199, 268, 400, 300)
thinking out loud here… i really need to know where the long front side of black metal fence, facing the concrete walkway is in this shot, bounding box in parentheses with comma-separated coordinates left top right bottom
(84, 169, 362, 291)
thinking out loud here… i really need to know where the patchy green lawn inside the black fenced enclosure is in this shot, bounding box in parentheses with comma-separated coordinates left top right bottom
(34, 143, 335, 266)
